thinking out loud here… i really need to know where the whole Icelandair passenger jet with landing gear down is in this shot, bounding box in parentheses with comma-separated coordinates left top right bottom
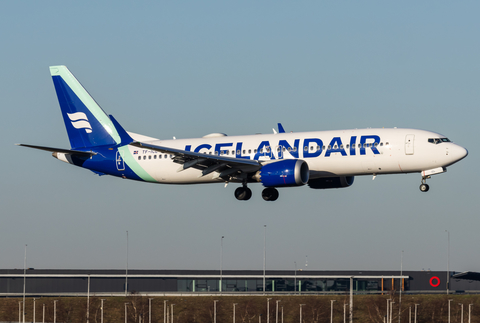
(17, 66, 468, 201)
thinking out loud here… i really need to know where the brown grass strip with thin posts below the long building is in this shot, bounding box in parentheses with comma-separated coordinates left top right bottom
(0, 294, 480, 323)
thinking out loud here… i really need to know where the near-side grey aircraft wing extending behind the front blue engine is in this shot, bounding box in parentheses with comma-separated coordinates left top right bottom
(130, 141, 262, 178)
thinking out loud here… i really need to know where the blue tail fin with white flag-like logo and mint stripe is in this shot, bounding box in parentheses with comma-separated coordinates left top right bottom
(50, 66, 125, 149)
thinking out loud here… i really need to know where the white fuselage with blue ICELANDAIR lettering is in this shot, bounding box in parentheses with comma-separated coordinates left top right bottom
(129, 128, 467, 184)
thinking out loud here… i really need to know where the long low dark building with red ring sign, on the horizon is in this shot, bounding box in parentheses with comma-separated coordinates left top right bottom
(0, 269, 480, 297)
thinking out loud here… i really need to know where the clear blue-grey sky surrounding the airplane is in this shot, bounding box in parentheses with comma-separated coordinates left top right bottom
(0, 1, 480, 271)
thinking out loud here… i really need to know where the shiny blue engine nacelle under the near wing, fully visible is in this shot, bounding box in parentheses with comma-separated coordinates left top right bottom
(253, 159, 310, 187)
